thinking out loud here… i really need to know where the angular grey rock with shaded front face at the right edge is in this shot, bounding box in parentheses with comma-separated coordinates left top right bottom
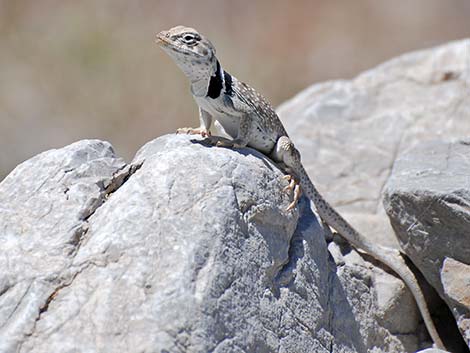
(384, 141, 470, 346)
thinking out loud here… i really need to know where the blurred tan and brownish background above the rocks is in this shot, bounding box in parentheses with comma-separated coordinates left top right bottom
(0, 0, 470, 180)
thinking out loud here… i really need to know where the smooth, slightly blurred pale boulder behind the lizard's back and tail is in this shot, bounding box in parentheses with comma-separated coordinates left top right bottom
(278, 39, 470, 245)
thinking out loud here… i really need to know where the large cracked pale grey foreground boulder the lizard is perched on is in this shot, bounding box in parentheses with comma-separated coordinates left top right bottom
(0, 135, 430, 353)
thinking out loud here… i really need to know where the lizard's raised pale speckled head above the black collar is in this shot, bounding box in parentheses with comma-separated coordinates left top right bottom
(156, 26, 217, 81)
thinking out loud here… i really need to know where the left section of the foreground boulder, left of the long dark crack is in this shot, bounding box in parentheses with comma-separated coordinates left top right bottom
(0, 140, 135, 352)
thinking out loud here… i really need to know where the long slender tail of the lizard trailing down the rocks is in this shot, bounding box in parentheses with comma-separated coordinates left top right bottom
(299, 167, 445, 349)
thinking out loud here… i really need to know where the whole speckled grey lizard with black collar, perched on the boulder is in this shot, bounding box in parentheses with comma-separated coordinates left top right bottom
(156, 26, 444, 348)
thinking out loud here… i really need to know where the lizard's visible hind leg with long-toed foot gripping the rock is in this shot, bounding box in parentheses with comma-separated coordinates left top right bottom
(271, 136, 302, 211)
